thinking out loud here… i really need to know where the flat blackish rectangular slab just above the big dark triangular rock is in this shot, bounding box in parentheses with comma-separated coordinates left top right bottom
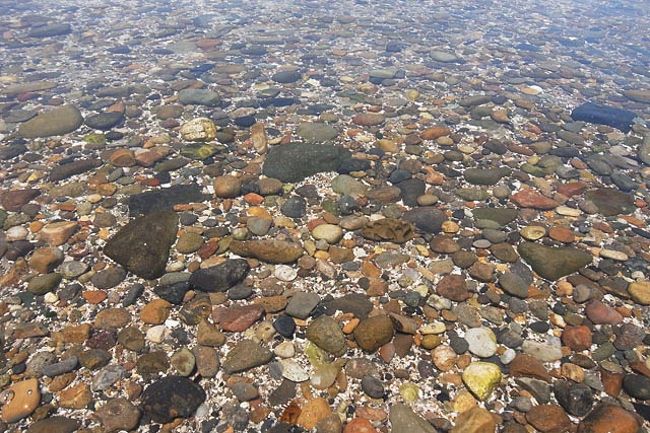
(128, 184, 204, 215)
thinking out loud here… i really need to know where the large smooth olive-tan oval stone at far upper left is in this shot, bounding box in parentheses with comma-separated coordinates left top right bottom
(18, 105, 84, 138)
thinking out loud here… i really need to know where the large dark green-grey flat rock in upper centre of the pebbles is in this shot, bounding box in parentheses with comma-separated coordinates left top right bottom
(263, 143, 352, 182)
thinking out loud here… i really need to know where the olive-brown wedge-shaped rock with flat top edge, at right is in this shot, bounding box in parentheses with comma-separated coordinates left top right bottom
(517, 242, 592, 281)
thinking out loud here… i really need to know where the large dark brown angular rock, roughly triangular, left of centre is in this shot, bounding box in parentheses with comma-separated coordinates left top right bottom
(104, 211, 178, 280)
